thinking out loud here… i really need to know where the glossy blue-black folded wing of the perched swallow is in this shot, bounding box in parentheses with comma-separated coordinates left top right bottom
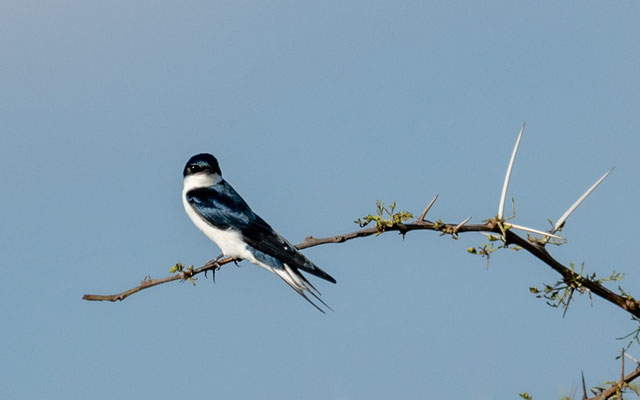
(186, 181, 336, 283)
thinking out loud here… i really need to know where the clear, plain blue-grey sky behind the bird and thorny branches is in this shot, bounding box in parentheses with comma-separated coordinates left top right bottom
(0, 0, 640, 400)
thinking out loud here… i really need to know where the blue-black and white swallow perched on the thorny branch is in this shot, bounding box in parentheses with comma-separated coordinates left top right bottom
(182, 153, 336, 313)
